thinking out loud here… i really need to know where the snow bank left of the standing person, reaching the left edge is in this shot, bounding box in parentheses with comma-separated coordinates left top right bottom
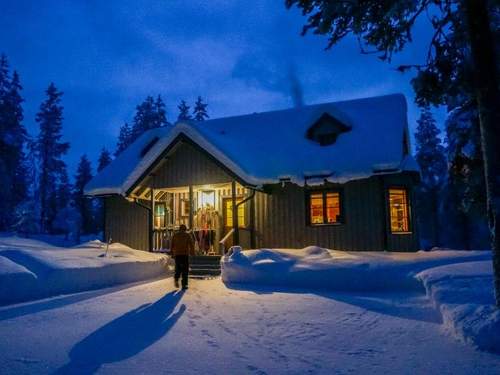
(0, 238, 169, 304)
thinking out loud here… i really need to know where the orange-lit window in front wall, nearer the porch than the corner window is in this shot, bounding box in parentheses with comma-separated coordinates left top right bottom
(309, 192, 341, 225)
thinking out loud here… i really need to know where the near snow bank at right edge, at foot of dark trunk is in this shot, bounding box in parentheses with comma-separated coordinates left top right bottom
(417, 261, 500, 352)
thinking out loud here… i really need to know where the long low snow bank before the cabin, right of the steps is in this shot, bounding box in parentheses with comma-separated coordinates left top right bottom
(221, 246, 491, 291)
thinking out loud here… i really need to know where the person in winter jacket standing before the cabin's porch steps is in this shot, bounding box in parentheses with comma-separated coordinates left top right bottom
(170, 224, 194, 289)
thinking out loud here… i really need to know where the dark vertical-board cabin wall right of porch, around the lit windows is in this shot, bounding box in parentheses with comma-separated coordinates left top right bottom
(255, 177, 418, 251)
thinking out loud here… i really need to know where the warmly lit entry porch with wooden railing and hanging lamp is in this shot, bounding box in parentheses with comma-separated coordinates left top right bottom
(134, 181, 255, 256)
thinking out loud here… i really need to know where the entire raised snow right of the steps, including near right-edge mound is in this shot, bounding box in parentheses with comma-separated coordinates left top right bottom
(222, 246, 500, 353)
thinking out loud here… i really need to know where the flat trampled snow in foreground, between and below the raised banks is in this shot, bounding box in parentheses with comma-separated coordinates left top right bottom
(0, 278, 500, 374)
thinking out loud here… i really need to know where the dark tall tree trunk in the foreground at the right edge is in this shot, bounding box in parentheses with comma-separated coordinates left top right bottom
(464, 0, 500, 307)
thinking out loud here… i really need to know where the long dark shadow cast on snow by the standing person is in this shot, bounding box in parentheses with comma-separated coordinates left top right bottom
(54, 291, 186, 374)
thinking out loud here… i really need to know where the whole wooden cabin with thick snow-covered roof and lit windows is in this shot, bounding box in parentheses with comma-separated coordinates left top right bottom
(85, 94, 419, 256)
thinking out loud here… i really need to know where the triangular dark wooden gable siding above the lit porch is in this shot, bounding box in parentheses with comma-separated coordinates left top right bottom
(146, 142, 233, 189)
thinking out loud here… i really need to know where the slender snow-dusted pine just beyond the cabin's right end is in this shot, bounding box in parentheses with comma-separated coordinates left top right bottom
(415, 106, 446, 247)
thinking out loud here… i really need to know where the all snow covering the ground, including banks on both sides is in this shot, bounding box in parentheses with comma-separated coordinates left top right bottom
(0, 237, 500, 374)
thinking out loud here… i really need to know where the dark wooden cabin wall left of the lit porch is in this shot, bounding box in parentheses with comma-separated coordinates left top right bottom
(104, 195, 149, 250)
